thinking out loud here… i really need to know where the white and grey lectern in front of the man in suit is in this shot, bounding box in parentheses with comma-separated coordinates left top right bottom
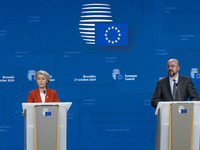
(155, 101, 200, 150)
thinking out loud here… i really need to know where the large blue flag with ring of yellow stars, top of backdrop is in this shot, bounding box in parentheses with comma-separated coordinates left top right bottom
(96, 23, 128, 46)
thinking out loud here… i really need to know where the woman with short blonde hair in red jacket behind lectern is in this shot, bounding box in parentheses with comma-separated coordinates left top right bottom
(28, 70, 60, 103)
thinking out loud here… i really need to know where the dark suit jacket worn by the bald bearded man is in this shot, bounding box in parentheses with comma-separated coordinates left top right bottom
(151, 75, 199, 108)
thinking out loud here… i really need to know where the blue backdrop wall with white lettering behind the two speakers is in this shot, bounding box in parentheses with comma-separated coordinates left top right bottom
(0, 0, 200, 150)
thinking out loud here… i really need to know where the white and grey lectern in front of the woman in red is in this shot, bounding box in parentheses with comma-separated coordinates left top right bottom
(22, 102, 72, 150)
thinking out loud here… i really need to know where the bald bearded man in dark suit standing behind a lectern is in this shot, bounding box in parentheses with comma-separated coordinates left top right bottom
(151, 59, 199, 108)
